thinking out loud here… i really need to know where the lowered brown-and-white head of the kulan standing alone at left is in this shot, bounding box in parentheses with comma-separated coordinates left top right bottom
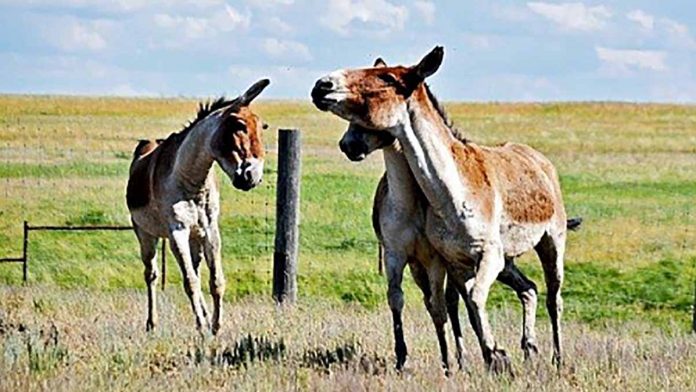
(210, 79, 270, 191)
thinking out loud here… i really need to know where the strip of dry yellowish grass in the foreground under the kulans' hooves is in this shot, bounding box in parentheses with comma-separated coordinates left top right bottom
(0, 286, 696, 391)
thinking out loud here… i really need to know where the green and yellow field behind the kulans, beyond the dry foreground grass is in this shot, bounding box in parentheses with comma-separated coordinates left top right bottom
(0, 96, 696, 330)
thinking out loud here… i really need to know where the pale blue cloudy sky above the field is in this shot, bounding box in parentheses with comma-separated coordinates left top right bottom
(0, 0, 696, 103)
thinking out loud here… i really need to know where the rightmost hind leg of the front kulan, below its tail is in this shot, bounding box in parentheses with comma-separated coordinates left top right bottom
(534, 233, 565, 368)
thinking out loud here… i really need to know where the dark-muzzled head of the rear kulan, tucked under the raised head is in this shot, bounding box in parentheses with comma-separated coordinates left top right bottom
(338, 58, 395, 162)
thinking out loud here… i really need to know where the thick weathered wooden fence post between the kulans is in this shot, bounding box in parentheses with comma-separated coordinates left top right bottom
(273, 129, 301, 304)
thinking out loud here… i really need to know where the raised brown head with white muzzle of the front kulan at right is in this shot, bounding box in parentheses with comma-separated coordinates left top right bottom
(311, 46, 444, 131)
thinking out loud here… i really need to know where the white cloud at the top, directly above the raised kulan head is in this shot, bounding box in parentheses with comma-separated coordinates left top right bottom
(320, 0, 408, 35)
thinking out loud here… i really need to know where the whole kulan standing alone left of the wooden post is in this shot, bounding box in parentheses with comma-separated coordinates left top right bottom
(126, 79, 270, 334)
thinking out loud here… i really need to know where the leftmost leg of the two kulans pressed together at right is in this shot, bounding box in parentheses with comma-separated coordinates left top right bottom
(385, 249, 408, 370)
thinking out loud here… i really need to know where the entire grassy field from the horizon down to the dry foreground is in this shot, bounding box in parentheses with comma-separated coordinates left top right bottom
(0, 96, 696, 390)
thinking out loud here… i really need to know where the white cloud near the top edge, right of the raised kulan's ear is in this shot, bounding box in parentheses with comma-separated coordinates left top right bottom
(527, 2, 612, 31)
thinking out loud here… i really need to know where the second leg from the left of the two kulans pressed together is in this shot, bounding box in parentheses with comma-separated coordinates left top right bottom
(409, 261, 449, 374)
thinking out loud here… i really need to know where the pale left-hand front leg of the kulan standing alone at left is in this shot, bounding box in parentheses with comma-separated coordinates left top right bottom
(169, 227, 207, 331)
